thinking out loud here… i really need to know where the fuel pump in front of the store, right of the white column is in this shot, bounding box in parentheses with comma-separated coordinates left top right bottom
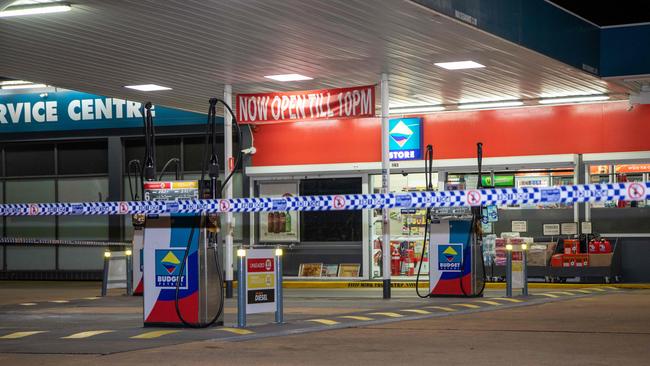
(416, 143, 485, 297)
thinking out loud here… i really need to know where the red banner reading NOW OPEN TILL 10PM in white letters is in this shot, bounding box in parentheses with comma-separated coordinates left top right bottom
(235, 85, 375, 124)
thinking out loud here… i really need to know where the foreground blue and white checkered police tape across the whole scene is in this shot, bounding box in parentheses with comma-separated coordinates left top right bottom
(0, 182, 650, 216)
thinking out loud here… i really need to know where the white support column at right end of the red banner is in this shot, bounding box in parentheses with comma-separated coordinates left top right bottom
(380, 73, 391, 299)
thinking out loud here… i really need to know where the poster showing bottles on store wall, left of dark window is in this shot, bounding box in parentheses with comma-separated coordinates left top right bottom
(259, 182, 300, 243)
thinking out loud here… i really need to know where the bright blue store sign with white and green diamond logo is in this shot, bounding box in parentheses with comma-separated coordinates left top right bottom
(388, 118, 422, 160)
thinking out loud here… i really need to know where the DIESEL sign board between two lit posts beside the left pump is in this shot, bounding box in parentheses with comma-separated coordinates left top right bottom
(246, 249, 277, 314)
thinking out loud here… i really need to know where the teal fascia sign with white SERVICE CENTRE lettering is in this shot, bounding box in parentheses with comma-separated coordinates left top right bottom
(0, 91, 205, 133)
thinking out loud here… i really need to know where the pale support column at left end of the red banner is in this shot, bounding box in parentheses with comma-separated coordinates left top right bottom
(223, 85, 234, 299)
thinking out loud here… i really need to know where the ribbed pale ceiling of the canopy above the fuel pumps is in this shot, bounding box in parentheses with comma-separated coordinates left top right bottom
(0, 0, 626, 112)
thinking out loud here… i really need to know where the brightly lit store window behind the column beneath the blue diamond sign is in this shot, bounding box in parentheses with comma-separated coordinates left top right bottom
(370, 173, 438, 279)
